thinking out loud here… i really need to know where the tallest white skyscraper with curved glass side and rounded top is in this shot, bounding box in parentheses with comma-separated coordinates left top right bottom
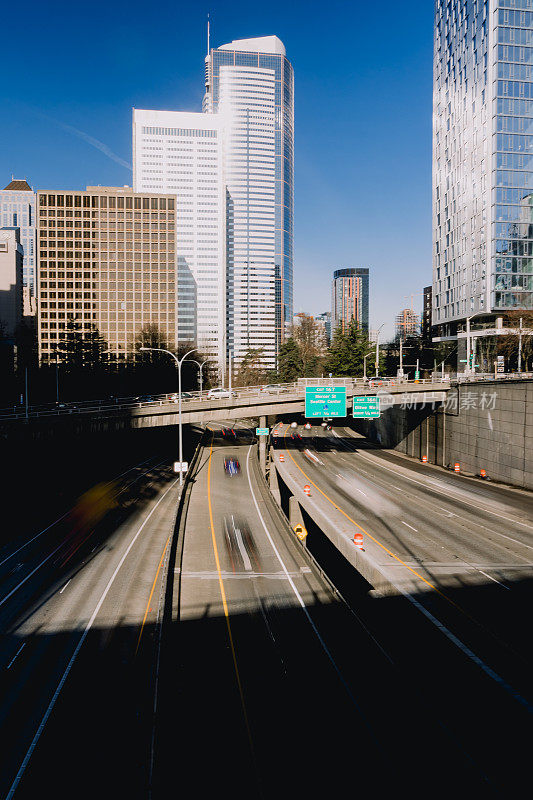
(203, 36, 294, 368)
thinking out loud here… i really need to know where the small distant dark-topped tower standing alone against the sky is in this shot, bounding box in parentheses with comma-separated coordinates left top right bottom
(331, 267, 369, 336)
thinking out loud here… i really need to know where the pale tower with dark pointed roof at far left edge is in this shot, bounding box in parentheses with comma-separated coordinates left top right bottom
(0, 179, 35, 302)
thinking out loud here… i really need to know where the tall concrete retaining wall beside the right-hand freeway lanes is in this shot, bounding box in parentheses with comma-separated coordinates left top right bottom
(353, 380, 533, 489)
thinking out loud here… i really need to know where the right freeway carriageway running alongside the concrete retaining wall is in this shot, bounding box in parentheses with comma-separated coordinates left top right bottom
(274, 424, 533, 791)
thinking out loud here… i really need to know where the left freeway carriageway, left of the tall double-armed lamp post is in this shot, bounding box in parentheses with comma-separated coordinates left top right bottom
(0, 444, 194, 798)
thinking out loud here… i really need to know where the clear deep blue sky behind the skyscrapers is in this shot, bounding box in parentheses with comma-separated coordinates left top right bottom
(0, 0, 433, 335)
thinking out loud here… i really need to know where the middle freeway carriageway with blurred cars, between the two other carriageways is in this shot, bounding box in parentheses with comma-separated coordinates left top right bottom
(151, 426, 524, 798)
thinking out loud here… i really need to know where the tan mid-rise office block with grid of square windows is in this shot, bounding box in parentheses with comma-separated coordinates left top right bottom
(37, 186, 177, 362)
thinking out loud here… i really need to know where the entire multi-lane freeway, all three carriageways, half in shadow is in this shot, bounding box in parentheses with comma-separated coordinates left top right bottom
(0, 424, 533, 798)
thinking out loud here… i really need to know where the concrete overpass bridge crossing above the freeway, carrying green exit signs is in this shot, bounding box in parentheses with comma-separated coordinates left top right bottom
(0, 378, 450, 431)
